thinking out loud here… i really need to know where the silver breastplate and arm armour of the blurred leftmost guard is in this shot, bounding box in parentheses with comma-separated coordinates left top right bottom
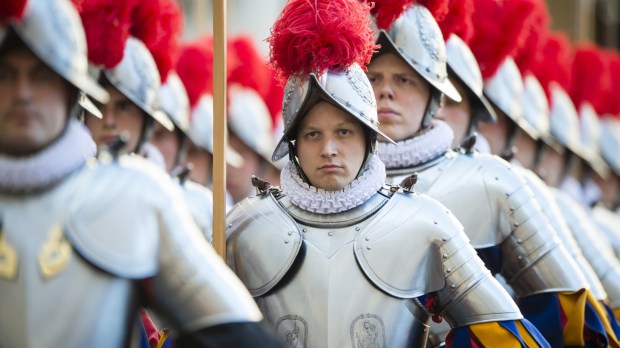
(0, 157, 261, 347)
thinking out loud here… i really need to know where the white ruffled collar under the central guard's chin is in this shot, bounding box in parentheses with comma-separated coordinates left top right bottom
(280, 156, 385, 214)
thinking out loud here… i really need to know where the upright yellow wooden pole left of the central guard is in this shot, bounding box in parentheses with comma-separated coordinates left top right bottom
(213, 0, 227, 259)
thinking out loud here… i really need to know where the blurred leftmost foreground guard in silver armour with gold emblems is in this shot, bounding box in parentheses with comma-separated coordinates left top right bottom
(0, 0, 278, 348)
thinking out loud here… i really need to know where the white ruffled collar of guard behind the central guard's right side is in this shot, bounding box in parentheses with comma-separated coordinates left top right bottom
(378, 120, 454, 169)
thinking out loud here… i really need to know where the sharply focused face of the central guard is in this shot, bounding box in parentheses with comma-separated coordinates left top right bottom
(295, 102, 366, 191)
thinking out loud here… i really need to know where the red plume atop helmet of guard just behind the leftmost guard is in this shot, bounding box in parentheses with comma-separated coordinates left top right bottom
(148, 0, 183, 82)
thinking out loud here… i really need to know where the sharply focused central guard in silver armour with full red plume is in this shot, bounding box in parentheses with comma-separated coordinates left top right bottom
(227, 0, 547, 347)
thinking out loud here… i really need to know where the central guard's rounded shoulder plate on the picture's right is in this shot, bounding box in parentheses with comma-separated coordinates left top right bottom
(354, 191, 468, 298)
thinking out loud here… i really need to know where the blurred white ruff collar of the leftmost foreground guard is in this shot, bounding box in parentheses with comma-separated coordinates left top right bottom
(0, 120, 97, 194)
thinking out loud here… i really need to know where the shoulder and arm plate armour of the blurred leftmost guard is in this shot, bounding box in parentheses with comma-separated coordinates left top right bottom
(67, 156, 261, 332)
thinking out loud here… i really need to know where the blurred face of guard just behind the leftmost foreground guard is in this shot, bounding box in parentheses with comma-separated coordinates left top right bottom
(86, 85, 147, 151)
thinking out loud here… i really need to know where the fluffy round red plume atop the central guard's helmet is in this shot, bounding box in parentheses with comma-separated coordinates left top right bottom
(268, 0, 376, 80)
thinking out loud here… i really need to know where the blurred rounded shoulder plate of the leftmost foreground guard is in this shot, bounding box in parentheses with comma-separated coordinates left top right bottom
(65, 156, 170, 278)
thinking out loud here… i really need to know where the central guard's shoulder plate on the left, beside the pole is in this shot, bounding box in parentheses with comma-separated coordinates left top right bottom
(226, 193, 302, 297)
